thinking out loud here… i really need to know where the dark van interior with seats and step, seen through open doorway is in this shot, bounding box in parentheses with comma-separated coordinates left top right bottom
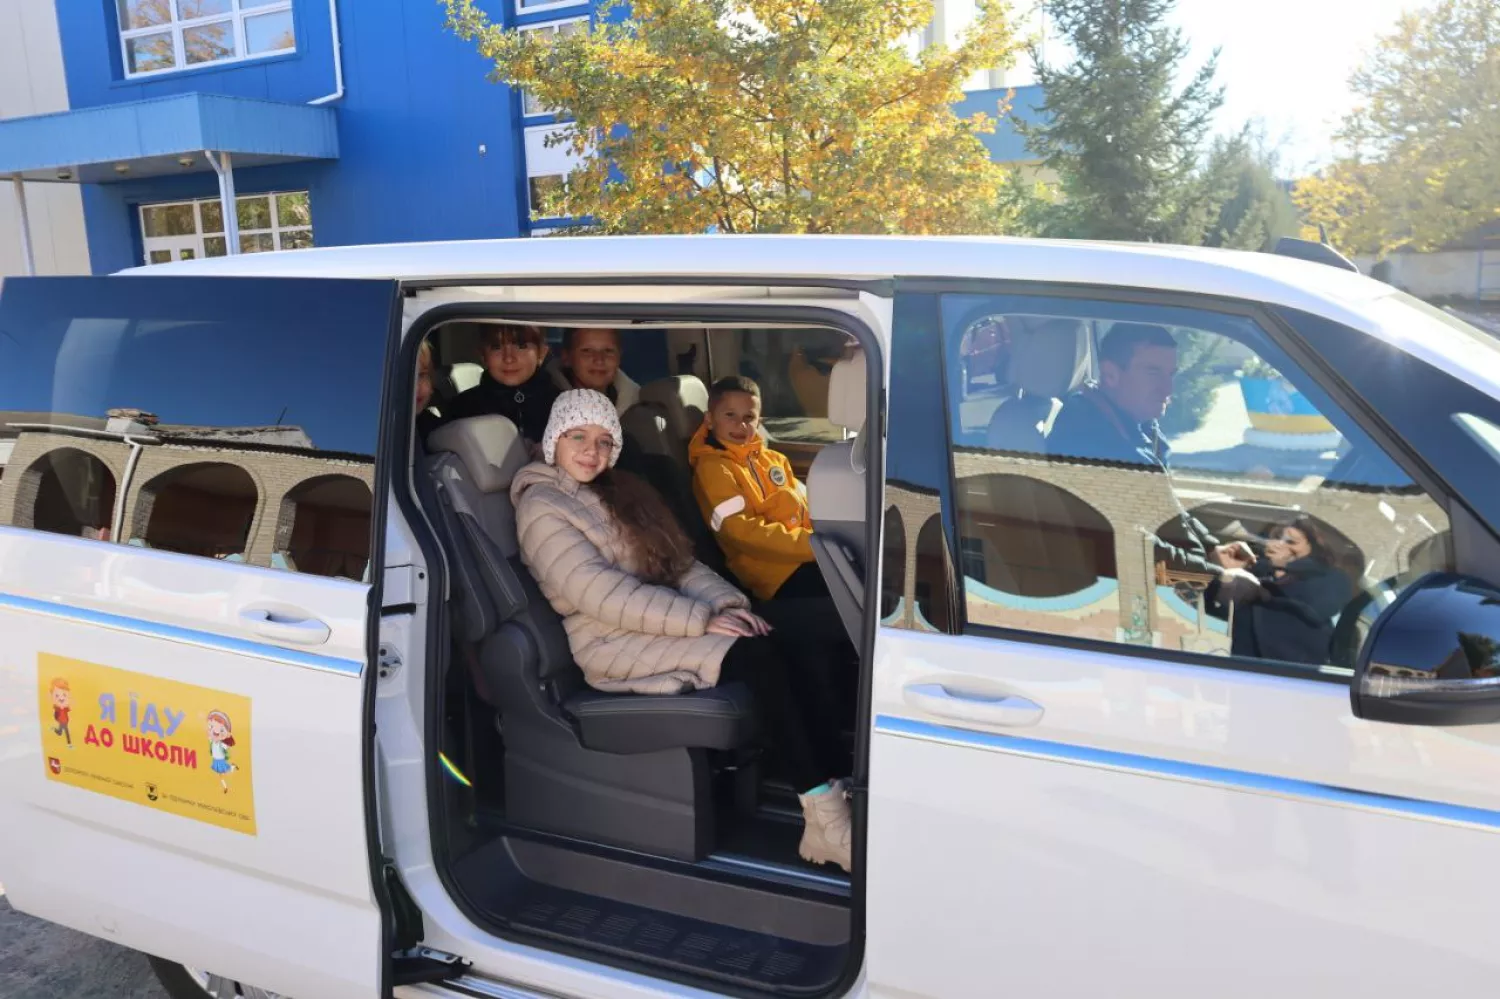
(417, 321, 867, 995)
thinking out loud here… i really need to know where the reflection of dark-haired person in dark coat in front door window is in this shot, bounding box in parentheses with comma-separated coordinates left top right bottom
(1205, 518, 1353, 666)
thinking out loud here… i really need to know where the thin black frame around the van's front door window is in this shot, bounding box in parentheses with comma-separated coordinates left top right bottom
(891, 278, 1470, 687)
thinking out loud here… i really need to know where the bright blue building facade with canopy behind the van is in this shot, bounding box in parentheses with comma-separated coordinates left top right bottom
(0, 0, 1044, 273)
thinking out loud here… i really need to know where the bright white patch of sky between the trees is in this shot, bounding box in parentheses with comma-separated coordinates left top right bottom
(1176, 0, 1434, 177)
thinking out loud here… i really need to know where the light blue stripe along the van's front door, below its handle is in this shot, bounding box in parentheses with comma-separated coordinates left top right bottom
(875, 714, 1500, 830)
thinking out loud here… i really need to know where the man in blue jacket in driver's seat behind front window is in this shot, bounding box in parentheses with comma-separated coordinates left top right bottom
(1047, 323, 1254, 576)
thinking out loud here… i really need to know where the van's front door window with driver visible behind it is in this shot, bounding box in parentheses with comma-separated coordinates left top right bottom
(941, 294, 1452, 669)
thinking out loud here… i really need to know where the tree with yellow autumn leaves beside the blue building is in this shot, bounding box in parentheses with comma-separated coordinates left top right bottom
(440, 0, 1017, 233)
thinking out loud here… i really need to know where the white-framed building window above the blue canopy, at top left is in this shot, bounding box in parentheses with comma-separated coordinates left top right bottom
(116, 0, 297, 77)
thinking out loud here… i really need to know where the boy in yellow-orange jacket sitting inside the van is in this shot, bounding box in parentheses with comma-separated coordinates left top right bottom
(687, 377, 828, 600)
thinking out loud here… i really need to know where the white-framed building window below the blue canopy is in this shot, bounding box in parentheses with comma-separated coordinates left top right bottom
(141, 191, 312, 264)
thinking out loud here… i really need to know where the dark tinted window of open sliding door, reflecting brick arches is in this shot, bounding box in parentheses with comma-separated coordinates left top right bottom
(0, 278, 393, 579)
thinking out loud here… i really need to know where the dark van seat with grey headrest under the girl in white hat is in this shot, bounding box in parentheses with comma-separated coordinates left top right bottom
(428, 416, 758, 860)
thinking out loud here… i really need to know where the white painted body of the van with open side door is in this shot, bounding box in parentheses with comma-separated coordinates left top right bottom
(0, 237, 1500, 999)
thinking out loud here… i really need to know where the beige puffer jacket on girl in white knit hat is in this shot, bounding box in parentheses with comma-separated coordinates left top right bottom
(510, 462, 750, 695)
